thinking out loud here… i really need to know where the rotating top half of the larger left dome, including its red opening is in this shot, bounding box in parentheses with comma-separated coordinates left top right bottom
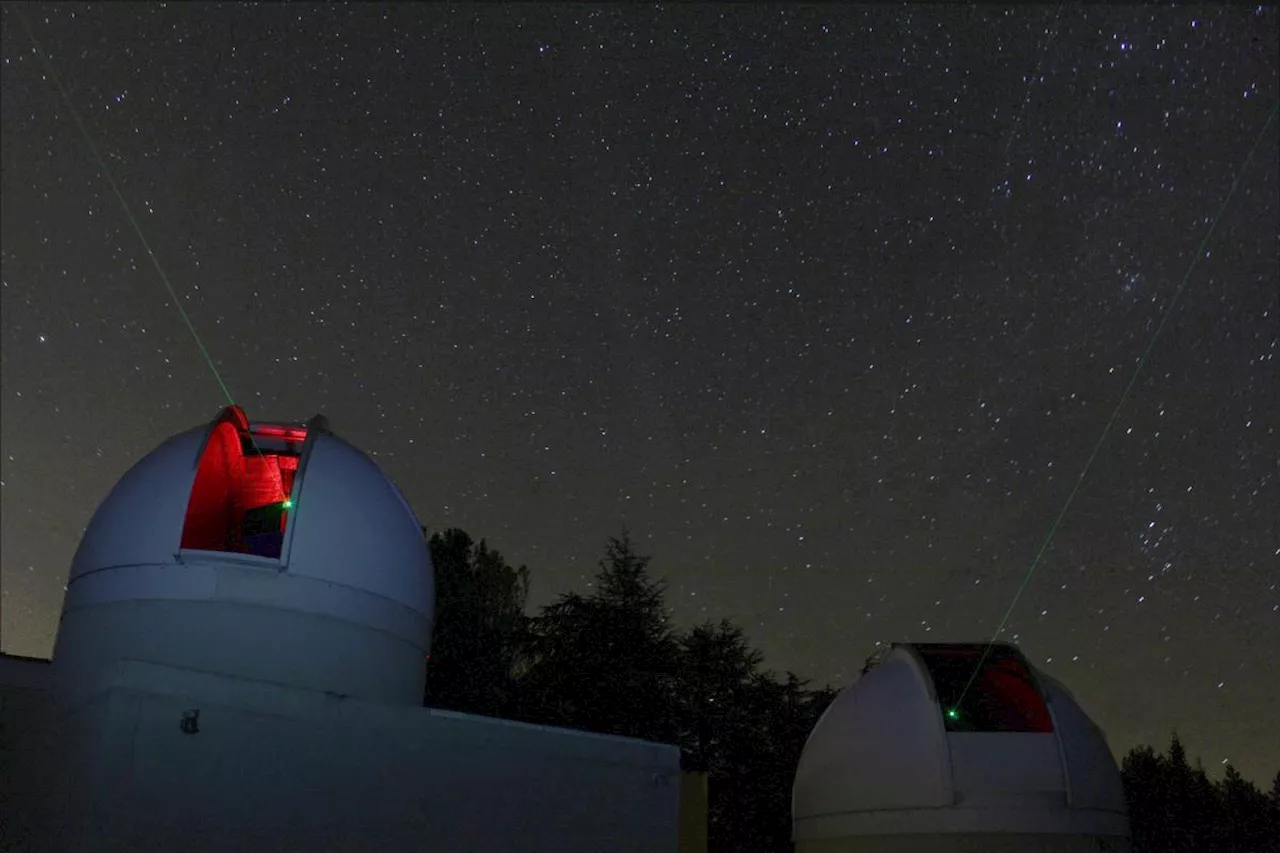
(68, 407, 435, 619)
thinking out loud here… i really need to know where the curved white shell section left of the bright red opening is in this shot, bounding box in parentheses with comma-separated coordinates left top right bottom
(68, 427, 210, 584)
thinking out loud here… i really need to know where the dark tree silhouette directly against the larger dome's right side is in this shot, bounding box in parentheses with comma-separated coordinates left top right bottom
(426, 529, 529, 716)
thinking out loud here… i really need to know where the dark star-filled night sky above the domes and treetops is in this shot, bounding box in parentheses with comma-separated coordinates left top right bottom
(0, 3, 1280, 780)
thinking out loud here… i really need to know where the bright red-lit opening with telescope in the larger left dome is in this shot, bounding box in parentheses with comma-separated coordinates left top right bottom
(182, 406, 307, 558)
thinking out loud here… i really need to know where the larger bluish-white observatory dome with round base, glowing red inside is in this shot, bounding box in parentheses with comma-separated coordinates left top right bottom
(54, 406, 435, 704)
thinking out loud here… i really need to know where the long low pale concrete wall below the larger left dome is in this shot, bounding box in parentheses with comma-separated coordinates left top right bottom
(37, 661, 681, 853)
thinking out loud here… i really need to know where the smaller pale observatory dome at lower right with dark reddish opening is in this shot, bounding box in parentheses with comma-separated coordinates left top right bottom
(792, 643, 1129, 853)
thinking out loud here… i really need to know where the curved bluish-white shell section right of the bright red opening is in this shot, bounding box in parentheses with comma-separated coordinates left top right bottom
(285, 435, 435, 616)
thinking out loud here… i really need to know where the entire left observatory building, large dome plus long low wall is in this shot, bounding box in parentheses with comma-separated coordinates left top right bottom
(0, 406, 681, 853)
